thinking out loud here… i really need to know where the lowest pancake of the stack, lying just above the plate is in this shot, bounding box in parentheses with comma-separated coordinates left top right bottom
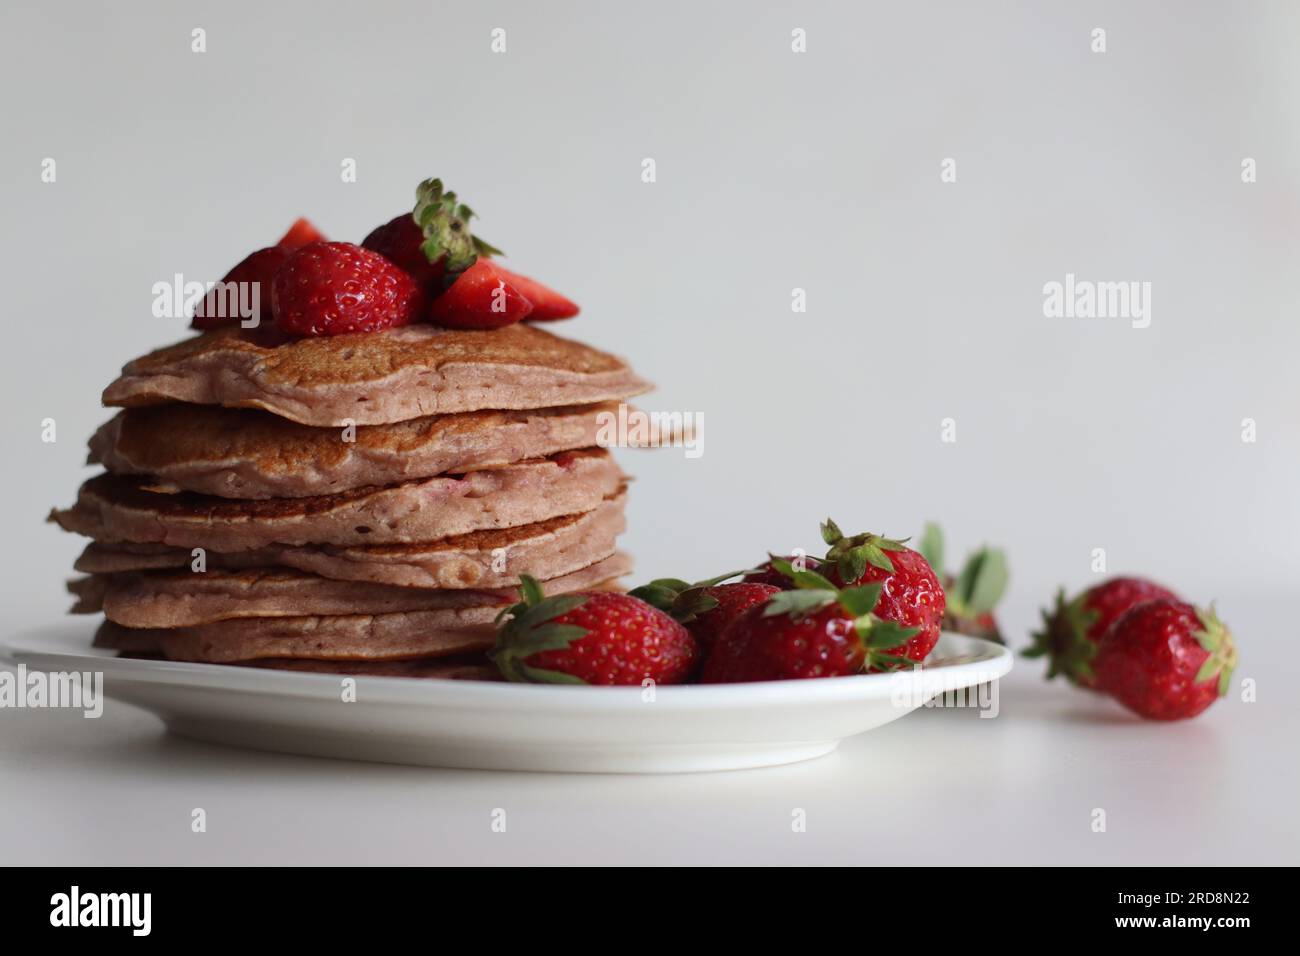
(95, 607, 501, 663)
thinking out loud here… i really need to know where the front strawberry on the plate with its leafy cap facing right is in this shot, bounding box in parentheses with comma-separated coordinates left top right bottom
(701, 559, 913, 684)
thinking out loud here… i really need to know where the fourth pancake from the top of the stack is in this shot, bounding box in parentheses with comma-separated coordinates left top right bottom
(75, 492, 627, 589)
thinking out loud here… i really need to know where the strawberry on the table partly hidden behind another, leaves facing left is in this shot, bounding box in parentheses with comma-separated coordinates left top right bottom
(1024, 578, 1178, 688)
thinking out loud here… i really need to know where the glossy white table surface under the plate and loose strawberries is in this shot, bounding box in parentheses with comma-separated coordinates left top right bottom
(0, 601, 1300, 865)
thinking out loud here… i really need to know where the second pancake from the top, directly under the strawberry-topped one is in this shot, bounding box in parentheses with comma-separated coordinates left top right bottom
(90, 402, 629, 498)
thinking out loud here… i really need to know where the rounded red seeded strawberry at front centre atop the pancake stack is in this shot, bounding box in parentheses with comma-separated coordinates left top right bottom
(270, 242, 426, 336)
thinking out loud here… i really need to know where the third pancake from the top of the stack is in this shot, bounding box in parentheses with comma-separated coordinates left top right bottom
(49, 449, 624, 551)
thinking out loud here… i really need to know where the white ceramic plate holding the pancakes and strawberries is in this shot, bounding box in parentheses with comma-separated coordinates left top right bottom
(0, 622, 1011, 773)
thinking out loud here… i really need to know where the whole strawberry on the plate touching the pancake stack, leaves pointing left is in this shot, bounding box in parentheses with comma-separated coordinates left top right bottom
(489, 575, 699, 684)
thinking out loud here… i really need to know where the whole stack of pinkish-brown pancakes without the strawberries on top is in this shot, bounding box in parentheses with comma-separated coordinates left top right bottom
(51, 325, 649, 678)
